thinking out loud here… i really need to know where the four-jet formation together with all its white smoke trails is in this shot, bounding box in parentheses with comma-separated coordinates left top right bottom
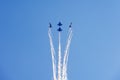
(48, 22, 72, 80)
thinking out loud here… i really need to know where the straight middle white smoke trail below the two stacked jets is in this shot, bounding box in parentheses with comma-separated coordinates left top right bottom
(58, 32, 62, 80)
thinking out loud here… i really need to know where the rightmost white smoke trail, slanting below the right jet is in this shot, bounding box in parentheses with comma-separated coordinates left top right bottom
(62, 28, 72, 80)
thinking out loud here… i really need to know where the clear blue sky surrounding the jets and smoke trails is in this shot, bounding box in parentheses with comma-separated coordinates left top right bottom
(0, 0, 120, 80)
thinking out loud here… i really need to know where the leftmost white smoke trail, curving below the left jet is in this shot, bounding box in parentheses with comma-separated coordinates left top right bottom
(48, 28, 57, 80)
